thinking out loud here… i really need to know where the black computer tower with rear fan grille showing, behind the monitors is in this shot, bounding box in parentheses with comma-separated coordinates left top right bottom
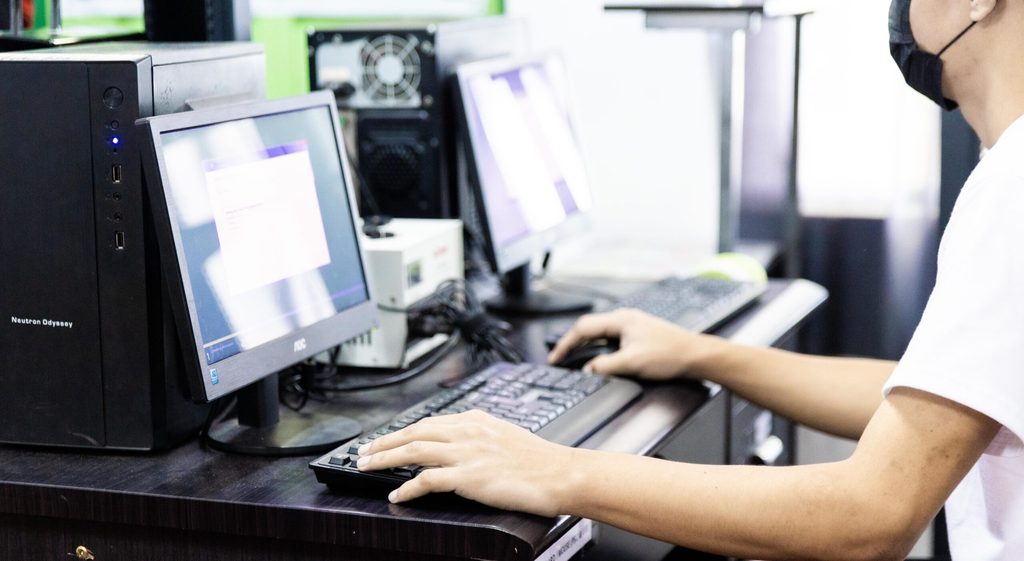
(308, 17, 527, 218)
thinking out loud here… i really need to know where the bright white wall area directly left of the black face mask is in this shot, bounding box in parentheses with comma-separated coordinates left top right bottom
(799, 0, 940, 218)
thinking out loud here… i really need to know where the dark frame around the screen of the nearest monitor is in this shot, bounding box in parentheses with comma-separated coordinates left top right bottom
(136, 91, 378, 402)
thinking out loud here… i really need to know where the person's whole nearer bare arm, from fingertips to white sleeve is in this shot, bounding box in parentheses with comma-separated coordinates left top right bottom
(368, 388, 1000, 561)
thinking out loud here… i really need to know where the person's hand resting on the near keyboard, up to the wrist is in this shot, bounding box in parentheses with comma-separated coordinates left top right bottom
(358, 411, 575, 516)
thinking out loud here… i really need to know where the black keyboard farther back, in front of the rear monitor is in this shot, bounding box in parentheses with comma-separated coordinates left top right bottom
(612, 276, 766, 333)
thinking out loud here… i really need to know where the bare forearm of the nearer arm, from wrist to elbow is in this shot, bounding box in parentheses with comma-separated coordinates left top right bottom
(564, 450, 917, 560)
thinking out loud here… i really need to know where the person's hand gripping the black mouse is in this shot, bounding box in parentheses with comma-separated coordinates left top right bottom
(548, 309, 729, 380)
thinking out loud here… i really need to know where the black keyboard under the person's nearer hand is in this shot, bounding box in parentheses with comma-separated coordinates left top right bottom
(309, 362, 642, 488)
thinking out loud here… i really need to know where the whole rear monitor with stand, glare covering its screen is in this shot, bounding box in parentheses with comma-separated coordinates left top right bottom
(458, 55, 592, 314)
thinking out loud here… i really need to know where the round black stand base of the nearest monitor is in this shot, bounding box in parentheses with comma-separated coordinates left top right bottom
(206, 409, 362, 456)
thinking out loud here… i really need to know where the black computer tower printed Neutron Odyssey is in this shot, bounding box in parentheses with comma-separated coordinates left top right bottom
(0, 43, 264, 449)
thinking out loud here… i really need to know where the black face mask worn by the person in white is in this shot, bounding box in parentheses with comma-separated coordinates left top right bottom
(889, 0, 977, 111)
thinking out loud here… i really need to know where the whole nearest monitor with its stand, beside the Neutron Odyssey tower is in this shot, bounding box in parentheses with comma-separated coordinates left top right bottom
(139, 92, 377, 455)
